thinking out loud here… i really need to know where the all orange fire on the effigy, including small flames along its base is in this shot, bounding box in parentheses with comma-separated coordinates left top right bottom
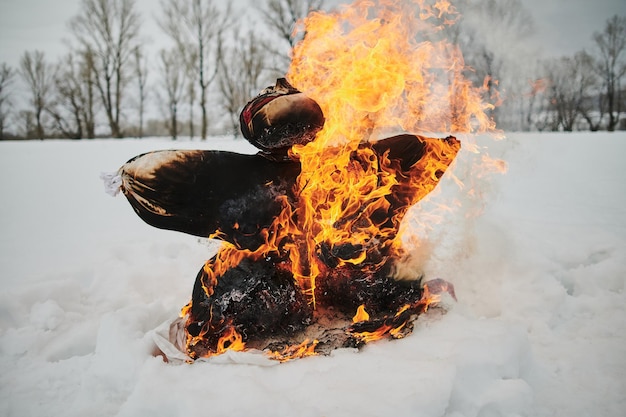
(183, 0, 499, 361)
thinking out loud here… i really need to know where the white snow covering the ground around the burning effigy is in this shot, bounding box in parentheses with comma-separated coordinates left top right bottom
(0, 132, 626, 417)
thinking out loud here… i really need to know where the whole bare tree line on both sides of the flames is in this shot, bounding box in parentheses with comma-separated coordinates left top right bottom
(0, 0, 626, 139)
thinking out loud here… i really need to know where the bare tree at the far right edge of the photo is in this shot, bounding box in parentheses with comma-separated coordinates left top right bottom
(593, 15, 626, 131)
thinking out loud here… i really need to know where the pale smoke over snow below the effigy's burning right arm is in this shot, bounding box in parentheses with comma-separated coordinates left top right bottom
(395, 135, 506, 283)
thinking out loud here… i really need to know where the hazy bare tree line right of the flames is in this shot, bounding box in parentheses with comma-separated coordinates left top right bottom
(447, 0, 626, 131)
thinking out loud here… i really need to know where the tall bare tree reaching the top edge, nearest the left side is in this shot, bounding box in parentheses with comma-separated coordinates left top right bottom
(70, 0, 141, 137)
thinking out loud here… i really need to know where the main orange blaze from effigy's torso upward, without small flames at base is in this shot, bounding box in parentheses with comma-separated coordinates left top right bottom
(287, 0, 495, 304)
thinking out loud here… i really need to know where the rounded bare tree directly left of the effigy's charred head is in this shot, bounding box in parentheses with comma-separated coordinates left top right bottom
(219, 31, 267, 136)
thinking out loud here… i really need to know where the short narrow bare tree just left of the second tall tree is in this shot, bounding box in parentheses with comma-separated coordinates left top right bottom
(159, 48, 186, 139)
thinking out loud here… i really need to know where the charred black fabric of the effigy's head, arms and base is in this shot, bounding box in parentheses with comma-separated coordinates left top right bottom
(112, 79, 460, 359)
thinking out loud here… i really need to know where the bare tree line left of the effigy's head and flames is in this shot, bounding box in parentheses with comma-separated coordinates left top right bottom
(0, 0, 322, 139)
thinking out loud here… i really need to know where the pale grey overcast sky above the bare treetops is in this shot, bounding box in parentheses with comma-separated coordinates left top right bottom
(0, 0, 626, 67)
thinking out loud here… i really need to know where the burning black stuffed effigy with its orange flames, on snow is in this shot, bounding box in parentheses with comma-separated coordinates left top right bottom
(105, 1, 492, 361)
